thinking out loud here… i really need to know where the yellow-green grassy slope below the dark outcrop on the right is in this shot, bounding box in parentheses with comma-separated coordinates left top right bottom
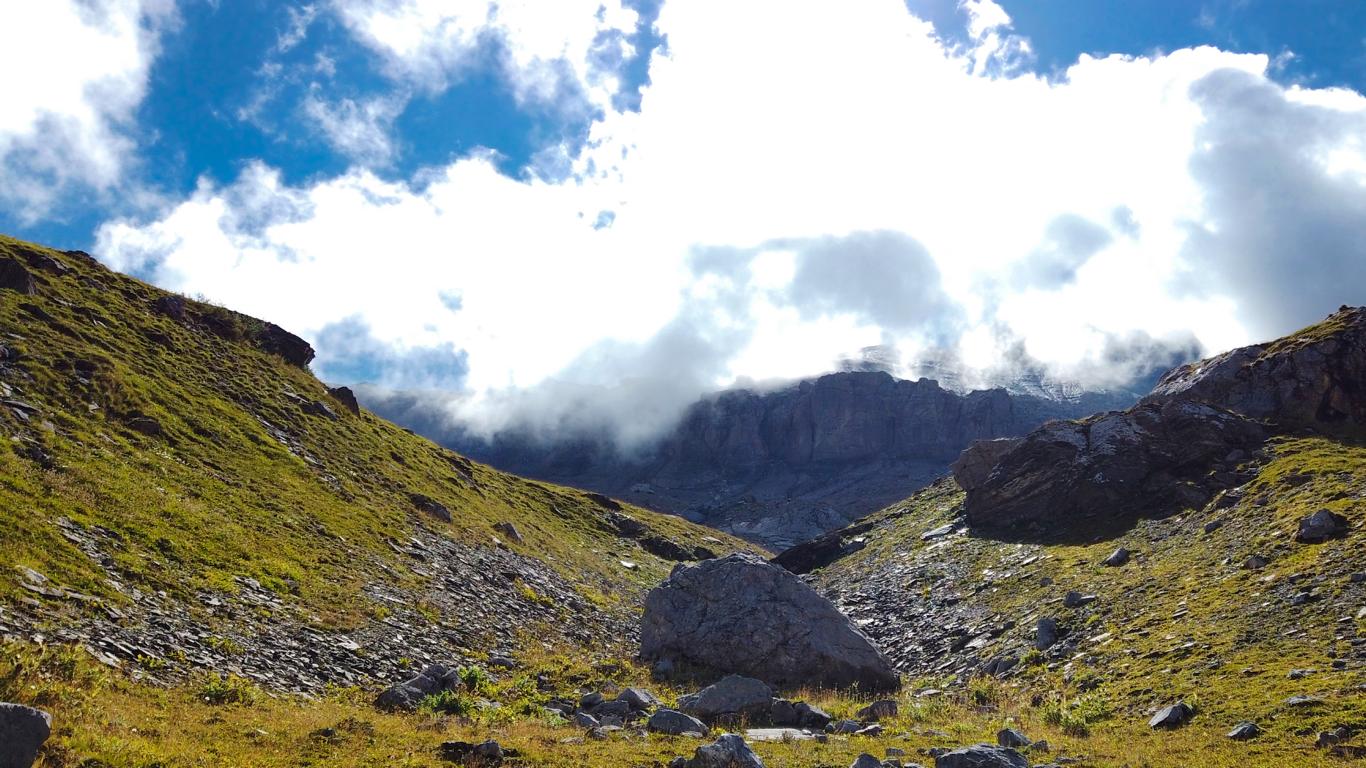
(816, 437, 1366, 765)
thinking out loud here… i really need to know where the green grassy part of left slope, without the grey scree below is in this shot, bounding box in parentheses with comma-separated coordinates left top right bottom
(0, 232, 739, 627)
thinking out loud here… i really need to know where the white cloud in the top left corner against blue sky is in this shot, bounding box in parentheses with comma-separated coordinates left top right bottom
(0, 0, 176, 219)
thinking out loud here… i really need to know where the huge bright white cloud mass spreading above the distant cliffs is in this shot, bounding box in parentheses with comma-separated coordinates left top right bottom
(100, 0, 1366, 442)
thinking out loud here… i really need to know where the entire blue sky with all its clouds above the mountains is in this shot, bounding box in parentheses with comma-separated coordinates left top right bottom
(0, 0, 1366, 445)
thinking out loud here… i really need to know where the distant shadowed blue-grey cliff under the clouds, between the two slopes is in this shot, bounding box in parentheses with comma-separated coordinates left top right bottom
(459, 372, 1132, 549)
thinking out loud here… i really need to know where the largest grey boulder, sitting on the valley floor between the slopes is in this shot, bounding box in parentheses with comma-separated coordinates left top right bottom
(641, 553, 900, 691)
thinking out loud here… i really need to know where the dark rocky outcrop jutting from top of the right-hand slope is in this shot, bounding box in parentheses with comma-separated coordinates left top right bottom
(955, 307, 1366, 536)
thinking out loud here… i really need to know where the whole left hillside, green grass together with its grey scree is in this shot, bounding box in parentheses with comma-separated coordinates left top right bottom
(0, 238, 740, 690)
